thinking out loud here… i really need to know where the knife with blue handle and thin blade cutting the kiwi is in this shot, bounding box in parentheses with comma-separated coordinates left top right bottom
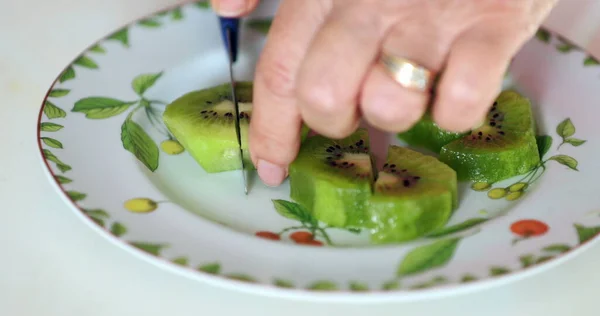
(219, 17, 248, 195)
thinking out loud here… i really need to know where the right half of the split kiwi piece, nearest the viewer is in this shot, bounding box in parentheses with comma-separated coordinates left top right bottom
(367, 146, 458, 244)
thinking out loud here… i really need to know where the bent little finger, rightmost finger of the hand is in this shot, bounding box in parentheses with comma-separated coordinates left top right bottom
(432, 23, 528, 132)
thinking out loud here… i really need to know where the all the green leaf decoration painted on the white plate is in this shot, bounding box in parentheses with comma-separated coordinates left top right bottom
(39, 1, 600, 292)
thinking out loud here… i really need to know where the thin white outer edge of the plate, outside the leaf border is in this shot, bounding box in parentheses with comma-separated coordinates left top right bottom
(35, 0, 600, 304)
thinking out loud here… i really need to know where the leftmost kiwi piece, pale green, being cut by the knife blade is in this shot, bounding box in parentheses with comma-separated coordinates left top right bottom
(163, 82, 308, 173)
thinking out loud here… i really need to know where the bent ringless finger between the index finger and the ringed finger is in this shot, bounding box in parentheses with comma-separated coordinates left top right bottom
(297, 2, 386, 138)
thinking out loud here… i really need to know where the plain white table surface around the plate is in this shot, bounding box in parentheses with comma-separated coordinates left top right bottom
(0, 0, 600, 316)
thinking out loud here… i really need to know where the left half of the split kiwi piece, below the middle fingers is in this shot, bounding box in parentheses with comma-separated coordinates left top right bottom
(289, 128, 374, 227)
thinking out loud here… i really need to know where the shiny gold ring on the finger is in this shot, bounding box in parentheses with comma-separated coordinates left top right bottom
(379, 53, 433, 92)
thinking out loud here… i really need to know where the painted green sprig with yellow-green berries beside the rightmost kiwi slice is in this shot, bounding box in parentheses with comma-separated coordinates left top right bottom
(471, 118, 586, 201)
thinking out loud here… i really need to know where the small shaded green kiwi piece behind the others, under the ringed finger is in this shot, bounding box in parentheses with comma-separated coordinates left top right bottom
(397, 112, 466, 153)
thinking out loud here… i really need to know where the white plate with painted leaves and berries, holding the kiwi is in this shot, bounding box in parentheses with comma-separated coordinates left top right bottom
(39, 3, 600, 302)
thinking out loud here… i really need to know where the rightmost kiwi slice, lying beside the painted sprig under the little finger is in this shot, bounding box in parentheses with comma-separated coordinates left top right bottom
(439, 91, 540, 183)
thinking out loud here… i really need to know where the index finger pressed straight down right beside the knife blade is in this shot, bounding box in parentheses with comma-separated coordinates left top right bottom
(249, 0, 325, 186)
